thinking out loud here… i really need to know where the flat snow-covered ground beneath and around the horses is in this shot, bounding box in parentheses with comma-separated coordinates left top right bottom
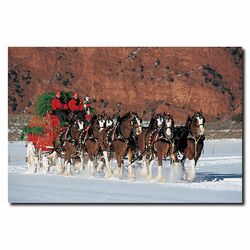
(9, 139, 242, 203)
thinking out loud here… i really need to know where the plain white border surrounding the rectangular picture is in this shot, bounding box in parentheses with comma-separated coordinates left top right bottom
(0, 0, 250, 250)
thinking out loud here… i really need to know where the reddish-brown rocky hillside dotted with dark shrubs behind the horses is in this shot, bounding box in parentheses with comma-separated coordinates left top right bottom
(8, 47, 243, 121)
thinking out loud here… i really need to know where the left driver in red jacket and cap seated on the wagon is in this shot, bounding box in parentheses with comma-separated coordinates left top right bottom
(51, 91, 68, 122)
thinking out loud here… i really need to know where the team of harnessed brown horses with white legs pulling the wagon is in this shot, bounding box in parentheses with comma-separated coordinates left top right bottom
(27, 112, 205, 182)
